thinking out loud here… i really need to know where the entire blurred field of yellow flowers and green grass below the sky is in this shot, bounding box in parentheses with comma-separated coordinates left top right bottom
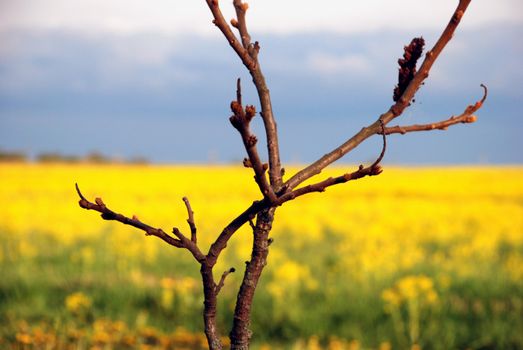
(0, 164, 523, 350)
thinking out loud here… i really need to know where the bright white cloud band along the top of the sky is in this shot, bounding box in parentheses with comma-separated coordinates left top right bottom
(0, 0, 523, 35)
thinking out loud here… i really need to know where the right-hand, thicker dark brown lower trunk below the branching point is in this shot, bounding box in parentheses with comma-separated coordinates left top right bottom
(230, 208, 275, 350)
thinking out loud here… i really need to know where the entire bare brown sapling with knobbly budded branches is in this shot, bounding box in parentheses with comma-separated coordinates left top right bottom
(76, 0, 487, 350)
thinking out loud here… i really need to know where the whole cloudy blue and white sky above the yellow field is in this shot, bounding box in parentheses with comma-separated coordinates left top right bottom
(0, 0, 523, 164)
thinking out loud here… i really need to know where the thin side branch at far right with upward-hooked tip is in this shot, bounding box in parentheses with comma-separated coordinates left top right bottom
(380, 84, 488, 135)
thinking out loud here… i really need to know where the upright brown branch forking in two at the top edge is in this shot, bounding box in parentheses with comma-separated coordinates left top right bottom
(206, 0, 282, 191)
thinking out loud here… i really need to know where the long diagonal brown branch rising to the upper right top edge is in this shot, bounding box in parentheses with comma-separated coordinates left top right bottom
(283, 0, 471, 191)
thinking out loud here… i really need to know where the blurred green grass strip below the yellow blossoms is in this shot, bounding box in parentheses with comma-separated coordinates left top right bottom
(0, 228, 523, 349)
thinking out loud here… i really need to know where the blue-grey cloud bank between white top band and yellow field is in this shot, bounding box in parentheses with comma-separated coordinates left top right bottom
(0, 26, 523, 162)
